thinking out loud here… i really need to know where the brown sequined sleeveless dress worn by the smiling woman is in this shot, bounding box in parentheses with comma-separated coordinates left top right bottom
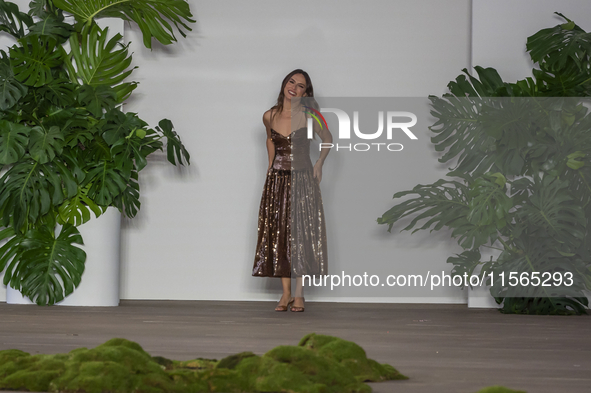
(252, 127, 327, 277)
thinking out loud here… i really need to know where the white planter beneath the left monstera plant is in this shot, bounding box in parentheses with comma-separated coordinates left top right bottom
(6, 207, 121, 307)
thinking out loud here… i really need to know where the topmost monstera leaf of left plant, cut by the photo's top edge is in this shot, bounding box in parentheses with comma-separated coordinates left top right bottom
(53, 0, 195, 48)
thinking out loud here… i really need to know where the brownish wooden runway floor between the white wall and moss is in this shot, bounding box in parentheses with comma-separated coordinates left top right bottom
(0, 300, 591, 393)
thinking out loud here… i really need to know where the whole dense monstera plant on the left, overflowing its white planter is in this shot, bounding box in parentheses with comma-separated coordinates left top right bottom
(0, 0, 194, 305)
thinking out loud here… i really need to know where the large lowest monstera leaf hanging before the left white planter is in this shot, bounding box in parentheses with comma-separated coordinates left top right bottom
(4, 224, 86, 306)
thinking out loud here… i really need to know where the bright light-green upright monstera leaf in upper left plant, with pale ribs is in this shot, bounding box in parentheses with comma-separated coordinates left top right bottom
(62, 25, 137, 102)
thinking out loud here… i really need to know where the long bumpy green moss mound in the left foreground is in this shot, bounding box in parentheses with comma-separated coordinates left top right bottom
(0, 334, 408, 393)
